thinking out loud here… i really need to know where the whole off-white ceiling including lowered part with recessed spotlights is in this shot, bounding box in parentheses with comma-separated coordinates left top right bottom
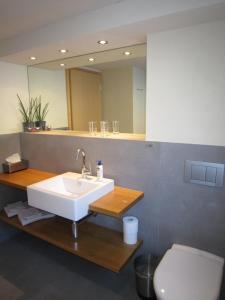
(0, 0, 225, 65)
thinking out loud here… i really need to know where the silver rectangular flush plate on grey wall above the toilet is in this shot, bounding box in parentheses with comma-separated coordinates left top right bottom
(184, 160, 224, 186)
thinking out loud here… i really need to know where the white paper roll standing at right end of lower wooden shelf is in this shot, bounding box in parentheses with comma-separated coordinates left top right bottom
(123, 216, 138, 245)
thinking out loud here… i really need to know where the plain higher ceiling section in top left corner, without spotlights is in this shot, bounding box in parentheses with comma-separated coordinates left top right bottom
(0, 0, 122, 41)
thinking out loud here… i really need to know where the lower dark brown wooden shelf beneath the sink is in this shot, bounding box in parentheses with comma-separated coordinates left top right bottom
(0, 211, 142, 273)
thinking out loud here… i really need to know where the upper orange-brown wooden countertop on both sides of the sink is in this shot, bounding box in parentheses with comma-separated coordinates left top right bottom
(0, 169, 144, 218)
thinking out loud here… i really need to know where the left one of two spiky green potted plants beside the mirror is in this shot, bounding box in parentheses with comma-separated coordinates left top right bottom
(17, 94, 37, 131)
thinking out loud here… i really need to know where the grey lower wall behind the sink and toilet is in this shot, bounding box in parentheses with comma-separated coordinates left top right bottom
(21, 133, 225, 256)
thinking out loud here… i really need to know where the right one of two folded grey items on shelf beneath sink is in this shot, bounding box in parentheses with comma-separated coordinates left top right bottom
(18, 207, 55, 226)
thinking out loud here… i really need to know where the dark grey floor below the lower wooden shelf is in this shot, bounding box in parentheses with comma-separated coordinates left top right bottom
(0, 233, 139, 300)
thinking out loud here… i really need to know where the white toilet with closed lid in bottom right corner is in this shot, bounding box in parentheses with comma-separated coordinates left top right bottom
(154, 244, 224, 300)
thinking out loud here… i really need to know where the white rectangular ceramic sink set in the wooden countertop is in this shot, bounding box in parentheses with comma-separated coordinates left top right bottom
(27, 172, 114, 221)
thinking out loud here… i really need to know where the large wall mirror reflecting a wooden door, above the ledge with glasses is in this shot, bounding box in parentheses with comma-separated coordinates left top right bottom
(28, 44, 146, 134)
